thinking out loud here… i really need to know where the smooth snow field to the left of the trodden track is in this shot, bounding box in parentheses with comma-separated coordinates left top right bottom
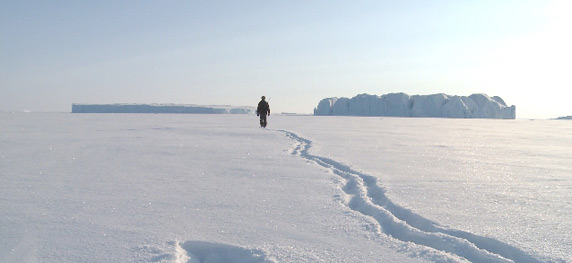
(0, 114, 426, 262)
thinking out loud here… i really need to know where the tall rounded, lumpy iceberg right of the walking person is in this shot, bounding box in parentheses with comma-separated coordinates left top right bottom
(314, 93, 516, 119)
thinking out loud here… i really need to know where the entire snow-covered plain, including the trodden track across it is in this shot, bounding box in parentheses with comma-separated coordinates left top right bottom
(0, 113, 572, 263)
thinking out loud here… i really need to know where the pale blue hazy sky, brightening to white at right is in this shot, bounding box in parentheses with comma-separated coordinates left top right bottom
(0, 0, 572, 118)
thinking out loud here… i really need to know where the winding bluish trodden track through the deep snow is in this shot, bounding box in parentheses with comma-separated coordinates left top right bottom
(280, 130, 542, 263)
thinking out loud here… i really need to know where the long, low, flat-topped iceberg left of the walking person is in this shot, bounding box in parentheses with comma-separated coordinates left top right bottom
(72, 103, 255, 114)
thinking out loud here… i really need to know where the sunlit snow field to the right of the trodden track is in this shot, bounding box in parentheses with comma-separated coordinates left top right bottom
(274, 117, 572, 262)
